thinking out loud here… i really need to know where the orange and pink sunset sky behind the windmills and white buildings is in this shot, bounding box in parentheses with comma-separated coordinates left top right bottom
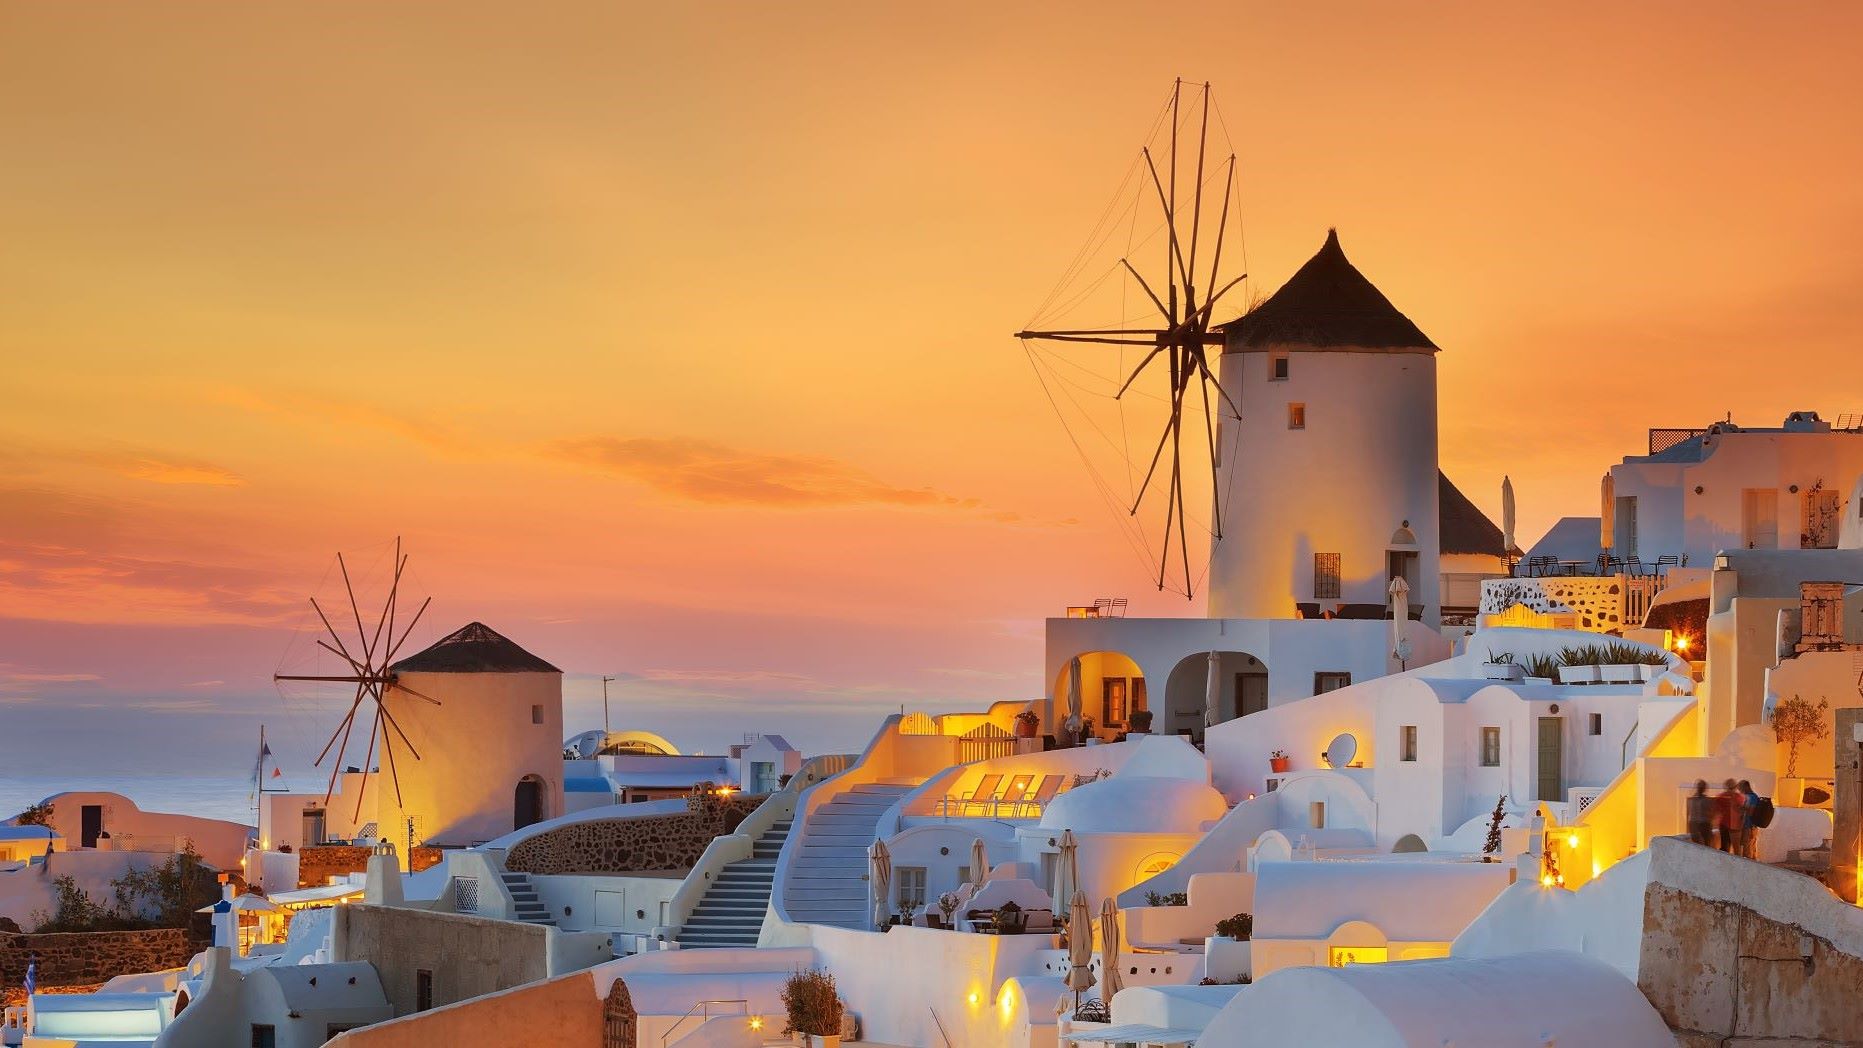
(0, 2, 1863, 780)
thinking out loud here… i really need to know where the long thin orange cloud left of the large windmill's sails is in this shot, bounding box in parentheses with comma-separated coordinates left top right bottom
(546, 437, 980, 510)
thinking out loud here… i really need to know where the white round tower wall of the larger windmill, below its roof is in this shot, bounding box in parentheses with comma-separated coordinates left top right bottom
(1209, 350, 1442, 625)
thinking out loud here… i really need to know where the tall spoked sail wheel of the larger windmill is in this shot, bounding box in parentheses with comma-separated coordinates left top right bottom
(1015, 80, 1248, 598)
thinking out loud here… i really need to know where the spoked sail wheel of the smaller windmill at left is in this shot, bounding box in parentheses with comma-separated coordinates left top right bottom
(272, 538, 440, 819)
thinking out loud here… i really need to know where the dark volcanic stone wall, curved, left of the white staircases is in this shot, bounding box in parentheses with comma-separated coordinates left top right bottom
(505, 797, 764, 873)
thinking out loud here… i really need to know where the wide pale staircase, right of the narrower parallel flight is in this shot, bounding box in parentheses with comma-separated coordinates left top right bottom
(782, 782, 917, 929)
